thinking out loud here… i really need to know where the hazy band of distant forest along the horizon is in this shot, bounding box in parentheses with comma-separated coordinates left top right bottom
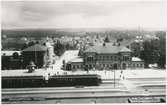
(1, 29, 157, 39)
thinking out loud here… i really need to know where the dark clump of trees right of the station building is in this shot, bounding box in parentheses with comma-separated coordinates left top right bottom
(133, 31, 166, 68)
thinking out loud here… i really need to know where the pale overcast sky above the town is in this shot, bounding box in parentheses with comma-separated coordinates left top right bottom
(2, 1, 166, 29)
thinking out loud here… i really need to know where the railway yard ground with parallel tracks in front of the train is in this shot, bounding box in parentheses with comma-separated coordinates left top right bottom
(2, 78, 166, 104)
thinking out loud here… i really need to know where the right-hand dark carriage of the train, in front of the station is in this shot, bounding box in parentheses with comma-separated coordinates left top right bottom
(47, 75, 101, 87)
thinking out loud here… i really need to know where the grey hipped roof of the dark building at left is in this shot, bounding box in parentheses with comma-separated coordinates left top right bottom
(22, 44, 47, 51)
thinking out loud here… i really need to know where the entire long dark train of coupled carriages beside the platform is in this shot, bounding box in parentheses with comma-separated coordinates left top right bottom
(2, 74, 101, 88)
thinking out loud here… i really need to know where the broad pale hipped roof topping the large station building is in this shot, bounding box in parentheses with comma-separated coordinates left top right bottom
(85, 45, 131, 54)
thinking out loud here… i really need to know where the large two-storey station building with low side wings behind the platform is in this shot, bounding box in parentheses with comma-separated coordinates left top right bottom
(66, 43, 144, 70)
